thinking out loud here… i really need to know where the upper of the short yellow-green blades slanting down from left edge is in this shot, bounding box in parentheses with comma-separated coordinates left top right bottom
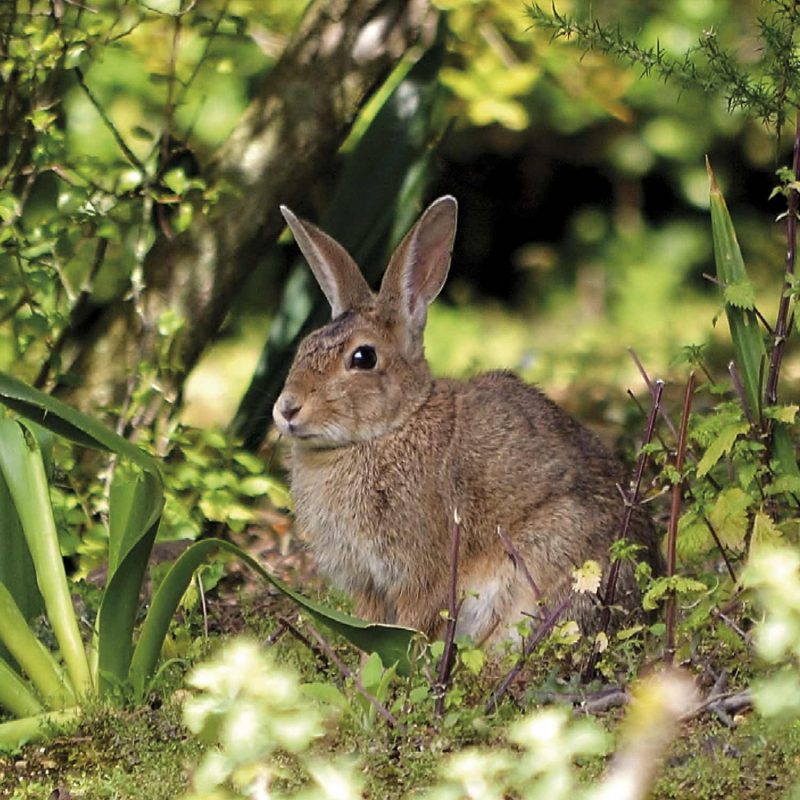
(0, 583, 75, 716)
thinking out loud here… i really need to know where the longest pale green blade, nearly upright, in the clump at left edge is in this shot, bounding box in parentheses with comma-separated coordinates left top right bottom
(0, 419, 93, 697)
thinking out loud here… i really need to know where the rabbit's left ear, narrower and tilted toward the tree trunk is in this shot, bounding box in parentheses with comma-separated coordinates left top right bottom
(281, 206, 374, 319)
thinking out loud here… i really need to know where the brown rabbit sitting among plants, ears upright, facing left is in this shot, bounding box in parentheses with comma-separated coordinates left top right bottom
(273, 196, 658, 641)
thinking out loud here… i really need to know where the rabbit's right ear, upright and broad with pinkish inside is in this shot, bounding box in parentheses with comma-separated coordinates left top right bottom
(378, 195, 458, 340)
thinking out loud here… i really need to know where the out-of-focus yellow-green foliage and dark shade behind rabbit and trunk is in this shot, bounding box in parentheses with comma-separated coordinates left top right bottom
(0, 0, 800, 450)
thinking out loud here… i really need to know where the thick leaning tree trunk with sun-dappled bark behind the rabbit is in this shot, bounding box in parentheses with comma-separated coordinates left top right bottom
(57, 0, 435, 418)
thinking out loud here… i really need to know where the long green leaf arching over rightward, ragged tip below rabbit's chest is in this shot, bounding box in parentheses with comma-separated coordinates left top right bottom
(130, 539, 416, 692)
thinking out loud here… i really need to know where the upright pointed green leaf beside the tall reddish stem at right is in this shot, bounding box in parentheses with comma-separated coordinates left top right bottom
(706, 159, 767, 419)
